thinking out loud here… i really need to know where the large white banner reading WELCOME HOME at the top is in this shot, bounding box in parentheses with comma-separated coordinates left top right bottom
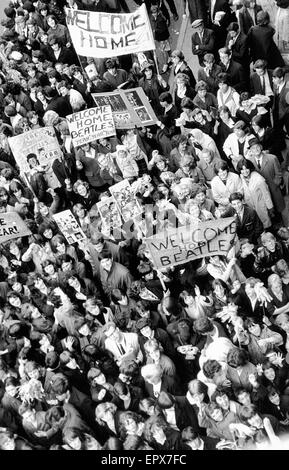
(66, 4, 155, 58)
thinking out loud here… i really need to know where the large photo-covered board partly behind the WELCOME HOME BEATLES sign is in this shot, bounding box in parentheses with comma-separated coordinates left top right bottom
(92, 87, 158, 129)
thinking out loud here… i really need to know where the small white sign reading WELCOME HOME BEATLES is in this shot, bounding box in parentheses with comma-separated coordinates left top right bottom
(66, 106, 115, 147)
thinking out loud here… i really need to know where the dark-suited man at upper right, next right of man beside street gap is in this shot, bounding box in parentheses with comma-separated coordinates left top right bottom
(225, 23, 249, 70)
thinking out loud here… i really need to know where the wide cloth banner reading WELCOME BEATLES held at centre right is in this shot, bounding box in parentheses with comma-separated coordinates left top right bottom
(145, 217, 236, 268)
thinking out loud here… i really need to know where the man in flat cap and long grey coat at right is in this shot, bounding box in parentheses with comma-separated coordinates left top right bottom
(246, 137, 285, 217)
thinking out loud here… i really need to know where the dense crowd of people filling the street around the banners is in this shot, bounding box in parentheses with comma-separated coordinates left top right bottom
(0, 0, 289, 451)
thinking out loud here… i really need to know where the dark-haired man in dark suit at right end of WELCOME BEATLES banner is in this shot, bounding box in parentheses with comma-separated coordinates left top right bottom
(229, 193, 264, 244)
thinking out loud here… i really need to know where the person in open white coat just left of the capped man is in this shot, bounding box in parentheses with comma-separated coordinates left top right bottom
(223, 121, 253, 170)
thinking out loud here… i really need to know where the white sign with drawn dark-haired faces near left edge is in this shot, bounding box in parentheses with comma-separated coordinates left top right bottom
(8, 127, 62, 173)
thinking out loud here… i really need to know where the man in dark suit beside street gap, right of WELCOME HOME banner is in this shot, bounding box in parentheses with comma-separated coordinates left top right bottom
(192, 19, 215, 65)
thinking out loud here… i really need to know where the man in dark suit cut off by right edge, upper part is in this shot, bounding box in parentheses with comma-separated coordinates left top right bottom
(273, 67, 289, 135)
